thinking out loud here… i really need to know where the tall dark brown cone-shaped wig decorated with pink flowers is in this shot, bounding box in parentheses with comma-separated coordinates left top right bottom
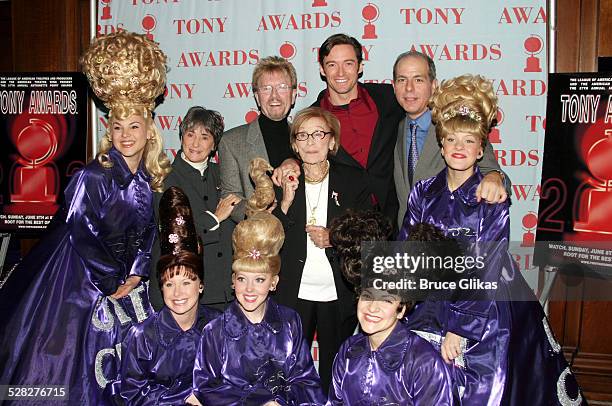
(157, 186, 204, 289)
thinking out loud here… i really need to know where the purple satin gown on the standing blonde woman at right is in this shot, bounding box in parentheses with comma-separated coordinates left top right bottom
(398, 167, 582, 406)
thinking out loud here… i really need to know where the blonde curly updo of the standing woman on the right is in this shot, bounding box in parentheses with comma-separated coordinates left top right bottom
(429, 74, 497, 147)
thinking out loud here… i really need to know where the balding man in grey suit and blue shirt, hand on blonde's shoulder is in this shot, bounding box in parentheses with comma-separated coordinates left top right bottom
(393, 51, 510, 227)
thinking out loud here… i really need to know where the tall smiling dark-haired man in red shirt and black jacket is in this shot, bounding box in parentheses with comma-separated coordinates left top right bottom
(313, 34, 403, 227)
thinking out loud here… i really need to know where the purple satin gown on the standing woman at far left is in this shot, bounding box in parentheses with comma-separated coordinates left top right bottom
(0, 149, 155, 405)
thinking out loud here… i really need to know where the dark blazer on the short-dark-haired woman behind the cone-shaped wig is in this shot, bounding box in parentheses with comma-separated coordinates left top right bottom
(149, 151, 235, 309)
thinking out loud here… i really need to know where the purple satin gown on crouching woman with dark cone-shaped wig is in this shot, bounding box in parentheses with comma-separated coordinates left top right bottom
(107, 305, 221, 406)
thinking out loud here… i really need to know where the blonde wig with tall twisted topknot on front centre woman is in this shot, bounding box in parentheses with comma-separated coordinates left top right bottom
(232, 158, 285, 275)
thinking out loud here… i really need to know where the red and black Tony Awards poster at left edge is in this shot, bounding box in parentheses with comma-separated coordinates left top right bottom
(0, 72, 87, 236)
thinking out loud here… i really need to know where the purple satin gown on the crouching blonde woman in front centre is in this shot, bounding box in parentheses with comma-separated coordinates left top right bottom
(193, 298, 325, 406)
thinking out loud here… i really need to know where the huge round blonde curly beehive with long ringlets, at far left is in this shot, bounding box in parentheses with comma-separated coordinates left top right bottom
(80, 31, 171, 192)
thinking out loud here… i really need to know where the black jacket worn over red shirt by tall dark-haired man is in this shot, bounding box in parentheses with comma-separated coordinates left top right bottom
(313, 83, 404, 228)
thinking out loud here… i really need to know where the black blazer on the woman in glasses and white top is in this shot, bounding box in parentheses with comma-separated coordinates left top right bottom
(273, 161, 372, 326)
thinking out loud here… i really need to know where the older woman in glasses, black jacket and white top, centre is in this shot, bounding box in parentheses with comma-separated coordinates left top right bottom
(274, 107, 370, 391)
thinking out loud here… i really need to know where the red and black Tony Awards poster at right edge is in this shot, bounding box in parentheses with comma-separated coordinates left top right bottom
(535, 72, 612, 277)
